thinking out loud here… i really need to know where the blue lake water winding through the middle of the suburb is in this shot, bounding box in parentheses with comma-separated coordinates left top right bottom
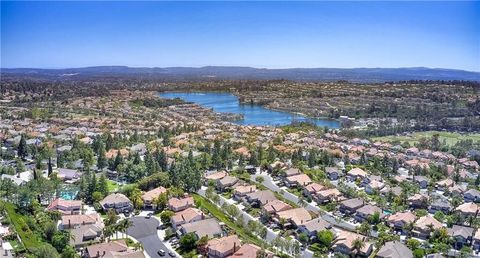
(160, 92, 340, 128)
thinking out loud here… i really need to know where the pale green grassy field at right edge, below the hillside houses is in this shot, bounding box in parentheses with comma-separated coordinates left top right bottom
(373, 131, 480, 145)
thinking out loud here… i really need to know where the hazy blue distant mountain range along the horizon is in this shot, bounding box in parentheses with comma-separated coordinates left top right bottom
(1, 66, 480, 82)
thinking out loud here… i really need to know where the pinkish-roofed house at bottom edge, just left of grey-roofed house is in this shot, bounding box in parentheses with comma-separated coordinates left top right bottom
(332, 231, 373, 257)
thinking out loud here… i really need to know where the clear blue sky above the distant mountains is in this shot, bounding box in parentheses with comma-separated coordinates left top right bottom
(1, 1, 480, 71)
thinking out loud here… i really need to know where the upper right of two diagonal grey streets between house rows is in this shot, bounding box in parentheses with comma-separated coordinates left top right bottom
(251, 173, 377, 237)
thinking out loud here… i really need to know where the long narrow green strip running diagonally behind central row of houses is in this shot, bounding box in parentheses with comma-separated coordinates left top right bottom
(193, 194, 262, 246)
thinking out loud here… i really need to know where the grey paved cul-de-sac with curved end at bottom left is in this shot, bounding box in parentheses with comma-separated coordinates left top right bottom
(127, 217, 176, 258)
